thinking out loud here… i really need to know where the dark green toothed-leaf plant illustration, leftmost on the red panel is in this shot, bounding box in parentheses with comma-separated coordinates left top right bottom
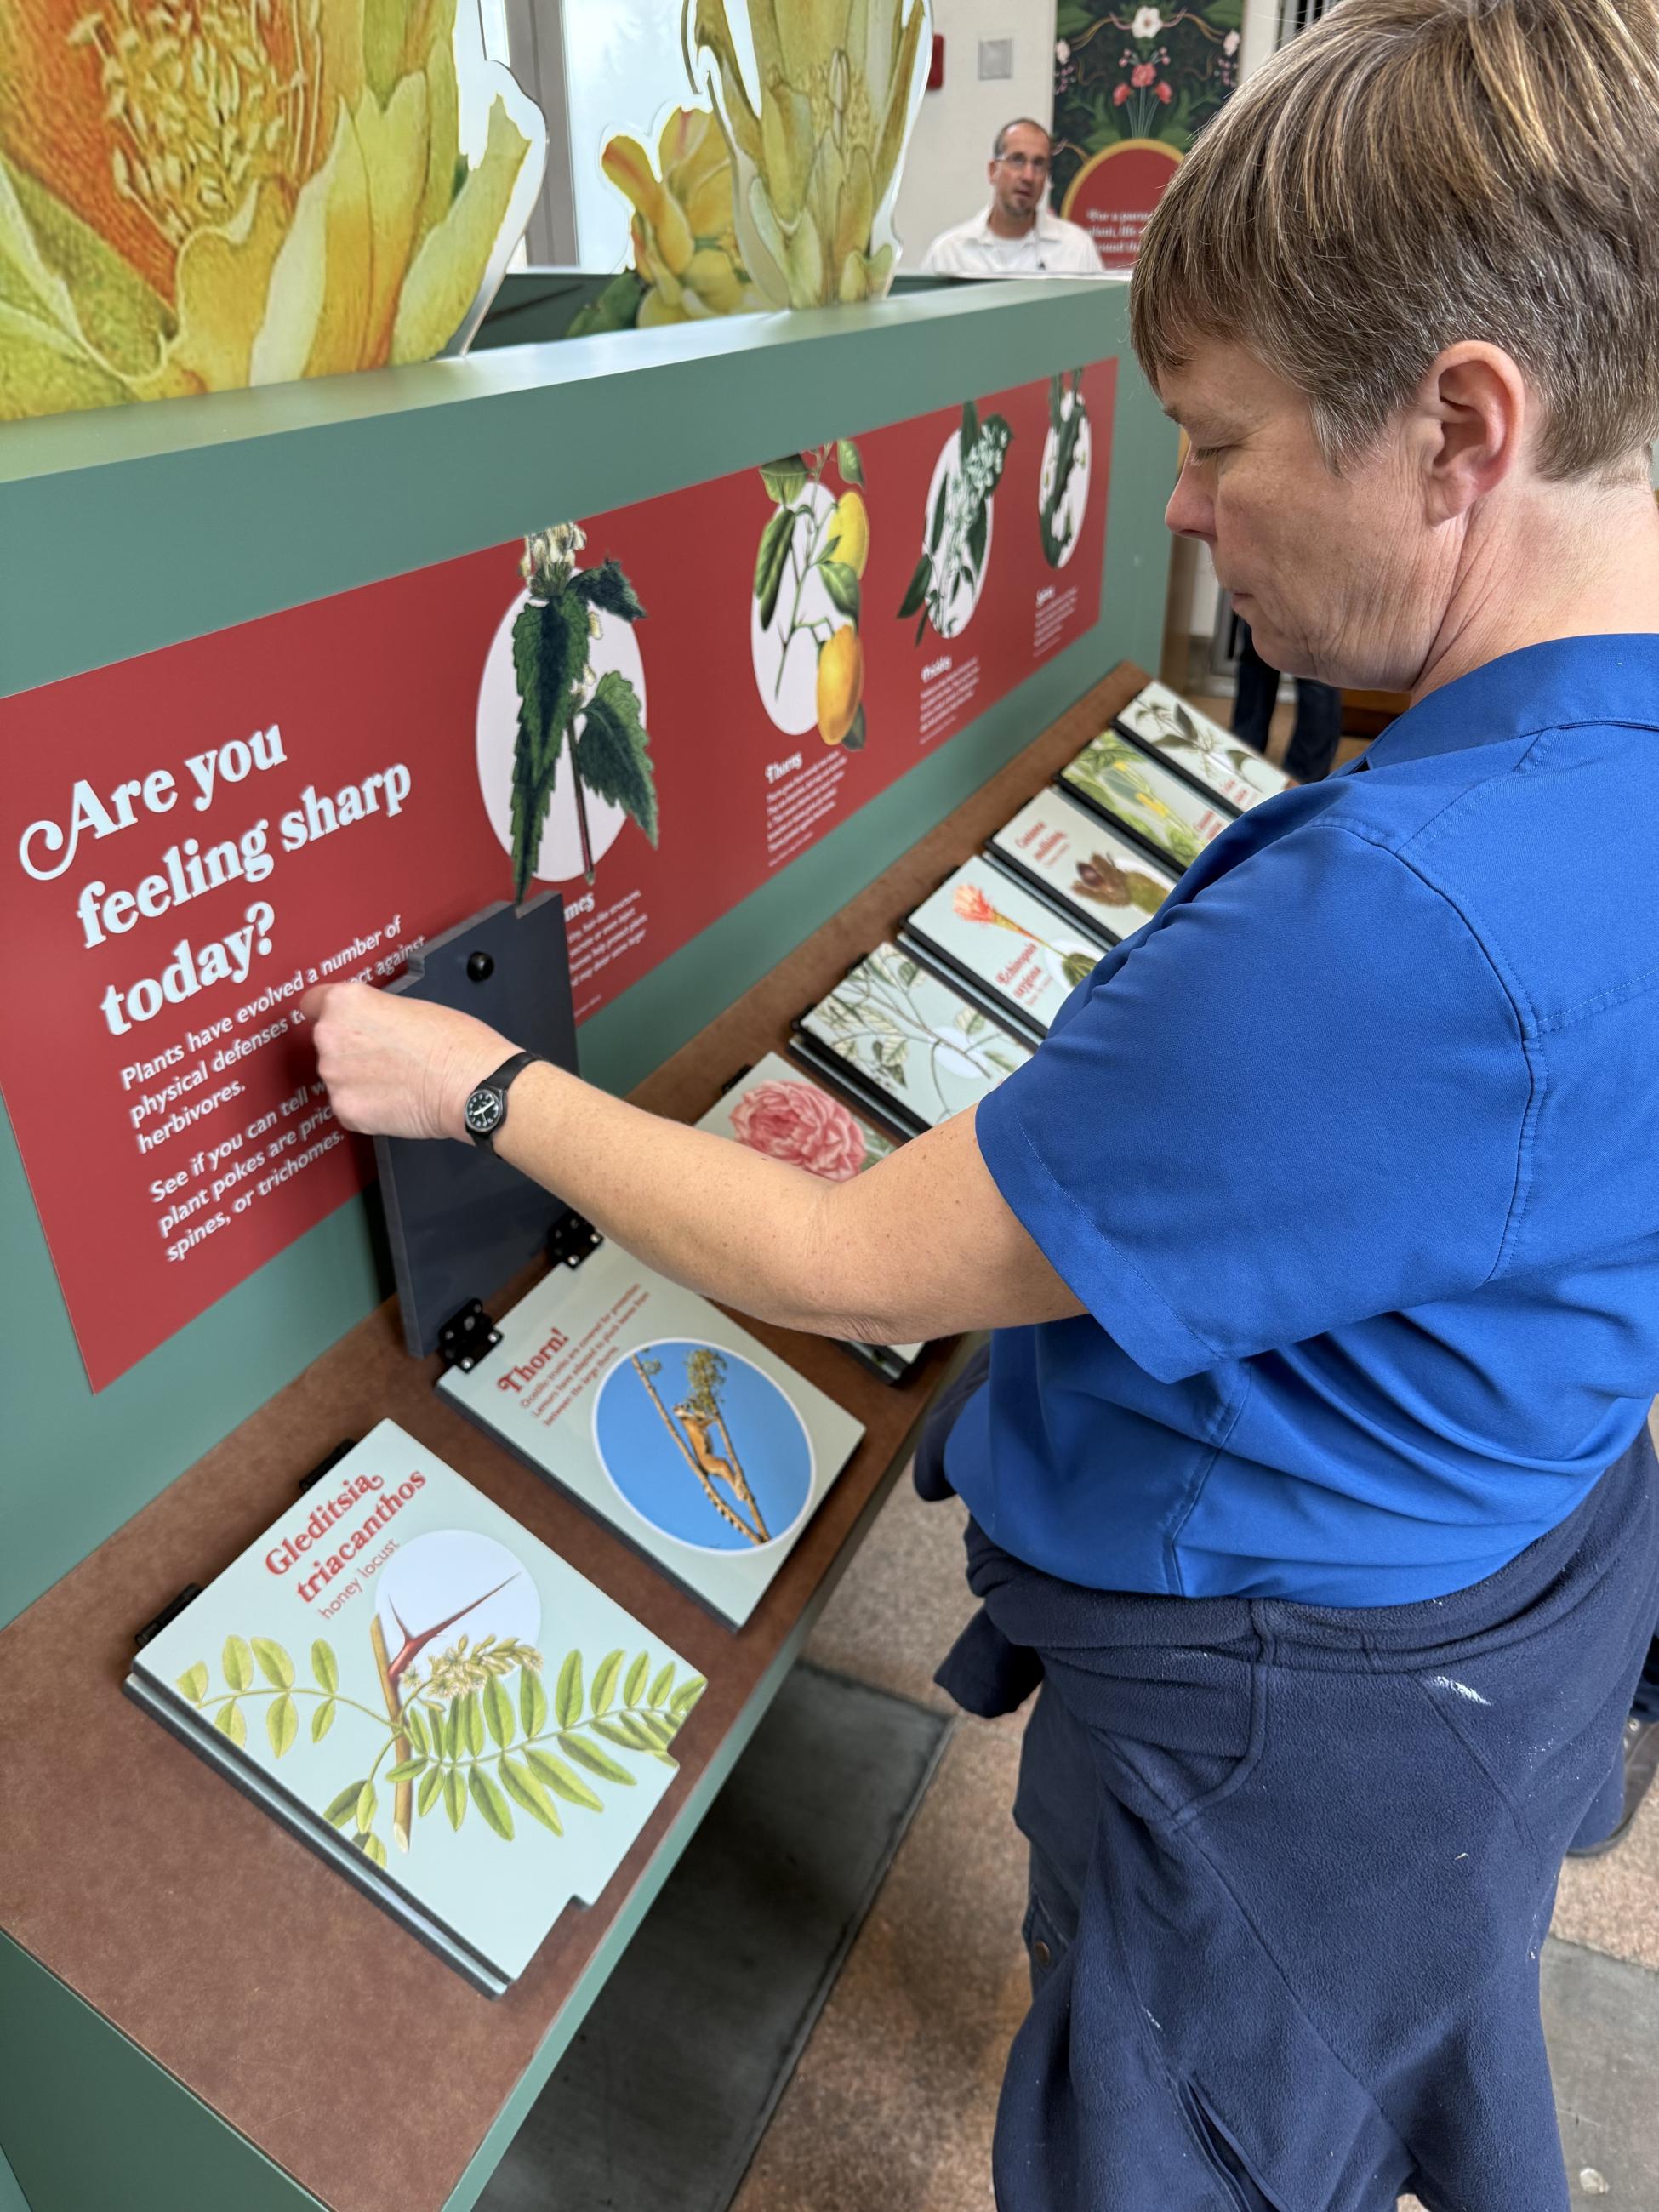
(513, 522, 657, 900)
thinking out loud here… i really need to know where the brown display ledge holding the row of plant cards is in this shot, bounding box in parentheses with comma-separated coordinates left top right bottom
(0, 664, 1146, 2212)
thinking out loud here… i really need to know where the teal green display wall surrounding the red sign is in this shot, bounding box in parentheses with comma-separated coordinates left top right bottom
(0, 283, 1175, 1622)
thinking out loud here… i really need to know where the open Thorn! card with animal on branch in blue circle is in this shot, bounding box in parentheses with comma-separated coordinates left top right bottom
(438, 1243, 865, 1628)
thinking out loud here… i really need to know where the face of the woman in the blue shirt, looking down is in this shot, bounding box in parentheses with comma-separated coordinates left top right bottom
(1159, 340, 1457, 690)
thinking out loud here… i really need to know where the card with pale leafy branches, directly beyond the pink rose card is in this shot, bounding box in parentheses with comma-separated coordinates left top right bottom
(790, 944, 1031, 1135)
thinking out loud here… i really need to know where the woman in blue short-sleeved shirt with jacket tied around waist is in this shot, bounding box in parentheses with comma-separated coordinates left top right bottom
(307, 0, 1659, 2212)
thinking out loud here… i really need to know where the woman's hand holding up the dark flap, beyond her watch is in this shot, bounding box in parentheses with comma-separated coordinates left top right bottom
(299, 982, 513, 1137)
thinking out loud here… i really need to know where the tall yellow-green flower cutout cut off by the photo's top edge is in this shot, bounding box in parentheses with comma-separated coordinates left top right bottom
(683, 0, 926, 307)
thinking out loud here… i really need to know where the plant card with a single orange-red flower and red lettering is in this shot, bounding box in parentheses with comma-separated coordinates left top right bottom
(898, 856, 1106, 1042)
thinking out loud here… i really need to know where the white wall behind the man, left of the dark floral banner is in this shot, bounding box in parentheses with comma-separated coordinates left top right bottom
(893, 0, 1055, 270)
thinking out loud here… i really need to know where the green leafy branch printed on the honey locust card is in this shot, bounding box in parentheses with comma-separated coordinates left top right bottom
(177, 1628, 705, 1867)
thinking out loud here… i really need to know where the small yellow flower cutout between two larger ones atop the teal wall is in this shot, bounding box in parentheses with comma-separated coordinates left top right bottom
(601, 108, 766, 328)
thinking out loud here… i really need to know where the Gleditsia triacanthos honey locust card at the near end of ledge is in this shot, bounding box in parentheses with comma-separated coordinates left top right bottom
(126, 1420, 704, 1995)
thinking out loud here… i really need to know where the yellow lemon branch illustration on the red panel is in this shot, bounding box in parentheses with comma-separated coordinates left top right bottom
(755, 438, 869, 752)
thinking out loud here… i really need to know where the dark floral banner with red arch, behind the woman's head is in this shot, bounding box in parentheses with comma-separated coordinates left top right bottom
(1053, 0, 1243, 270)
